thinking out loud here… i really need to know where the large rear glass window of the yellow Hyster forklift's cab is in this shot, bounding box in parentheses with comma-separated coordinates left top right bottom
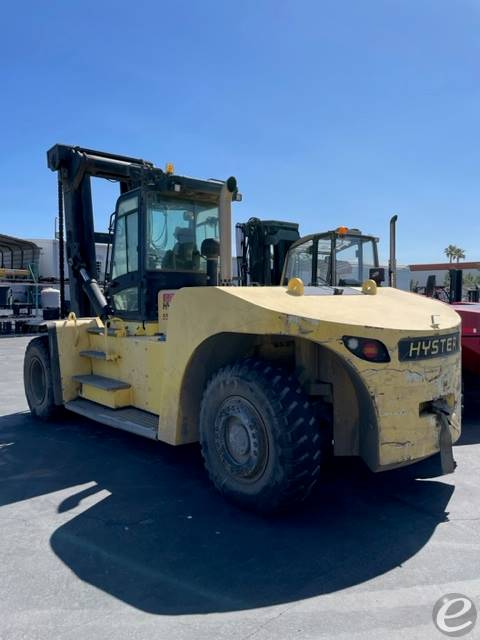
(146, 192, 219, 272)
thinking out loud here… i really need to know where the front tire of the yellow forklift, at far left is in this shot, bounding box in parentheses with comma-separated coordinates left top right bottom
(23, 336, 59, 420)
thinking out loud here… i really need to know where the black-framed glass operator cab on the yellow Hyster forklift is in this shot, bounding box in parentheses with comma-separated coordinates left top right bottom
(108, 187, 220, 319)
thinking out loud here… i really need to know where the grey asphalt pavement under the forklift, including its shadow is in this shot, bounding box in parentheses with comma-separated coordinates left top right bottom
(0, 338, 480, 640)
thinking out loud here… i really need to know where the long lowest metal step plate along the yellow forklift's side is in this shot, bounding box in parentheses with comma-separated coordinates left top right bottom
(65, 398, 158, 440)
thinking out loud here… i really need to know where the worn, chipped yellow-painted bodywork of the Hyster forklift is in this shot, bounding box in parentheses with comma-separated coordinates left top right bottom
(51, 287, 460, 469)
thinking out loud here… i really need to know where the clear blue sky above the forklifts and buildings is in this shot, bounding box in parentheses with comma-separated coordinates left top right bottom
(0, 0, 480, 263)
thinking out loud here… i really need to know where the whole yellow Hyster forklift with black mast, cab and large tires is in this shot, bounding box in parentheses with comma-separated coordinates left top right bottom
(24, 145, 461, 512)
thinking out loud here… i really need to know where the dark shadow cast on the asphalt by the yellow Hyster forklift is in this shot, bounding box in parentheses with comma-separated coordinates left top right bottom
(0, 414, 454, 615)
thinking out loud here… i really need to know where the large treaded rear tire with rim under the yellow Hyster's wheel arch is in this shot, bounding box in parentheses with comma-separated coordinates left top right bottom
(200, 359, 329, 513)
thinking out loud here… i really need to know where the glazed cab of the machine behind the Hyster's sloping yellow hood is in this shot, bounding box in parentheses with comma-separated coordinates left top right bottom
(282, 227, 384, 287)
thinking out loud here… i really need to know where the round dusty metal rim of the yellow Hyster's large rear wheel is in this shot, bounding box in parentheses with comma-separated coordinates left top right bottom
(215, 396, 268, 482)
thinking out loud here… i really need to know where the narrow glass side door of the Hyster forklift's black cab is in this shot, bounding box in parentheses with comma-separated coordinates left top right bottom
(108, 190, 140, 319)
